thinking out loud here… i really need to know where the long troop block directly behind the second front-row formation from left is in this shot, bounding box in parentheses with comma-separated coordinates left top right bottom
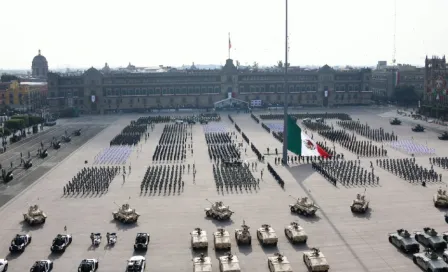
(152, 124, 188, 162)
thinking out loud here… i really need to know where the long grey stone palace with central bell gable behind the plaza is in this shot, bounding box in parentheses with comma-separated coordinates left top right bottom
(48, 59, 372, 113)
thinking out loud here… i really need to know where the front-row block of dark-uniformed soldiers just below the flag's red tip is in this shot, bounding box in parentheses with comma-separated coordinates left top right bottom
(312, 160, 380, 186)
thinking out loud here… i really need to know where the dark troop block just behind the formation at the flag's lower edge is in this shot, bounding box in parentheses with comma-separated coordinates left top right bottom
(318, 130, 387, 157)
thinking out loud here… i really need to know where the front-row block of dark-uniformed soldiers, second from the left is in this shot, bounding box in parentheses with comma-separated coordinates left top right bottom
(140, 165, 185, 195)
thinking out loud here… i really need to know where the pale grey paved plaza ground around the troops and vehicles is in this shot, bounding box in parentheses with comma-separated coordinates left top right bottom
(0, 108, 448, 272)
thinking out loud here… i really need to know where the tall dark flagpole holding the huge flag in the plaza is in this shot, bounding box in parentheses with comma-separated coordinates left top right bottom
(283, 0, 289, 165)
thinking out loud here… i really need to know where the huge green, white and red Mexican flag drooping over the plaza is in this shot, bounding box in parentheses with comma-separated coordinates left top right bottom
(287, 116, 330, 158)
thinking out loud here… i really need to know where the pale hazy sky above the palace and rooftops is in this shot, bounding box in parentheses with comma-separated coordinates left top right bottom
(0, 0, 448, 69)
